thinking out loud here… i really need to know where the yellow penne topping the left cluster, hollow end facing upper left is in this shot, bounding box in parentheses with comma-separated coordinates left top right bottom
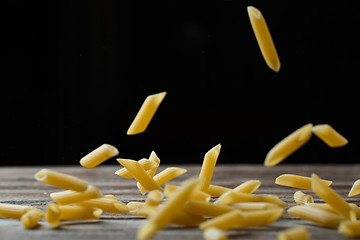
(35, 169, 89, 191)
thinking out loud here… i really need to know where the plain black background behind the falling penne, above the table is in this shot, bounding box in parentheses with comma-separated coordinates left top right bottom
(0, 0, 360, 165)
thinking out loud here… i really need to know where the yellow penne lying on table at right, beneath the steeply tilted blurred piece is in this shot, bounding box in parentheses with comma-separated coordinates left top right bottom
(287, 205, 346, 227)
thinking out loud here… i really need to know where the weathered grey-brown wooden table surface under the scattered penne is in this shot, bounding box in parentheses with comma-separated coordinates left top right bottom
(0, 164, 360, 240)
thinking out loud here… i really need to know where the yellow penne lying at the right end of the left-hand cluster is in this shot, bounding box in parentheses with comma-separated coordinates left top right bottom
(75, 197, 129, 213)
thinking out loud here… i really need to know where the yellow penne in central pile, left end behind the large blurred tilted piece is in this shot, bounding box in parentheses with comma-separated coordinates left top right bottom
(184, 199, 234, 217)
